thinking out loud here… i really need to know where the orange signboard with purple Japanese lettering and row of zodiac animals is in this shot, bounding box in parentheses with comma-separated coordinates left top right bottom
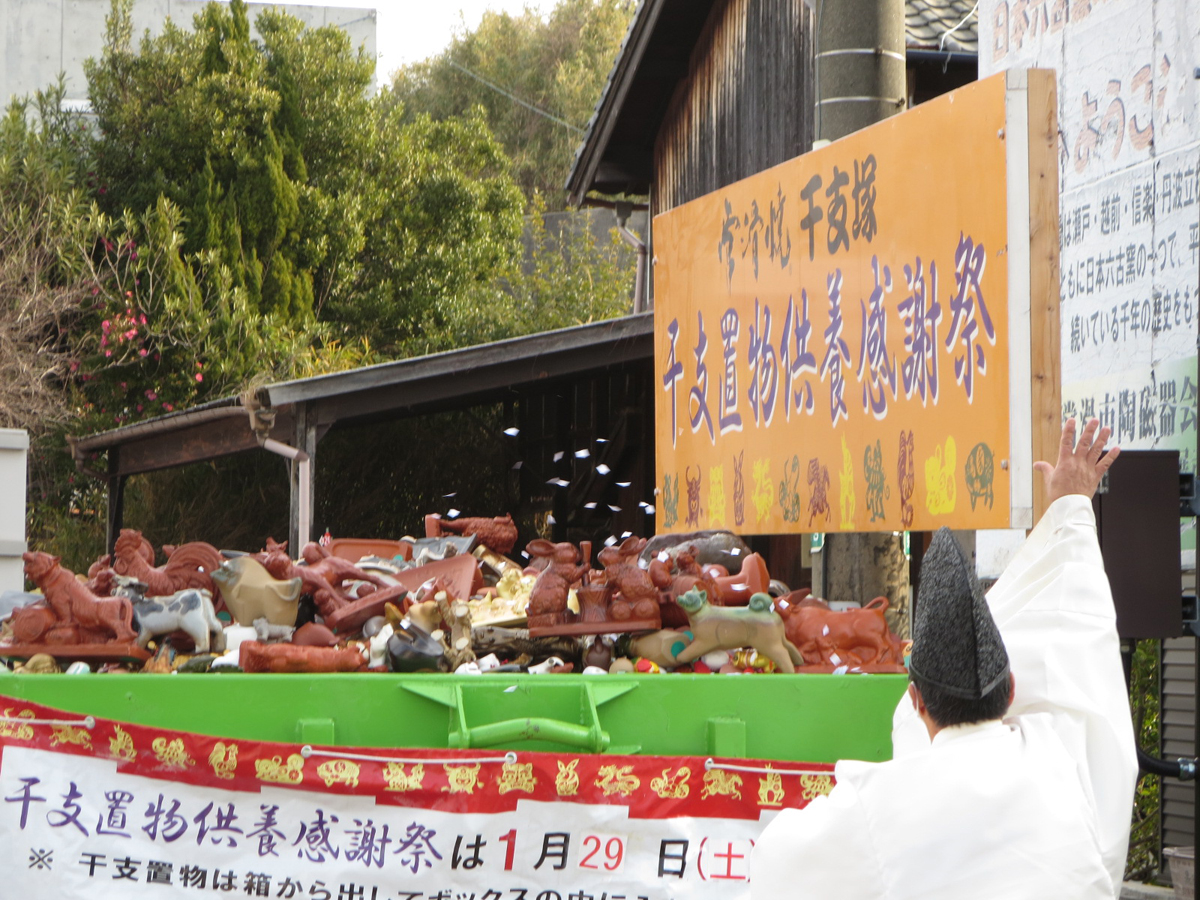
(654, 76, 1056, 534)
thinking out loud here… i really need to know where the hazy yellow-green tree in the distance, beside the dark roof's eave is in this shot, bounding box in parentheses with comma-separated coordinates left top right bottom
(390, 0, 635, 209)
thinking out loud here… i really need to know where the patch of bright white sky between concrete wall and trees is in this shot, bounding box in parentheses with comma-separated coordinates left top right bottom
(316, 0, 556, 84)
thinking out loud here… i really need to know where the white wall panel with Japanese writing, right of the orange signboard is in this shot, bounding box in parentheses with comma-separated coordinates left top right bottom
(979, 0, 1200, 470)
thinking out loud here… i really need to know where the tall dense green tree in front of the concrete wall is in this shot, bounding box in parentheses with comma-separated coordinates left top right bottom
(85, 0, 373, 318)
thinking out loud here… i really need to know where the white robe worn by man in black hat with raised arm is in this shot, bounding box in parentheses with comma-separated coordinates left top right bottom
(750, 494, 1138, 900)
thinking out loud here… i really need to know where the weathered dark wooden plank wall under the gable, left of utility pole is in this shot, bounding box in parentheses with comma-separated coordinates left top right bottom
(650, 0, 814, 214)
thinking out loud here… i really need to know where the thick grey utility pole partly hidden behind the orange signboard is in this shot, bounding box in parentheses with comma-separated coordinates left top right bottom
(812, 0, 910, 637)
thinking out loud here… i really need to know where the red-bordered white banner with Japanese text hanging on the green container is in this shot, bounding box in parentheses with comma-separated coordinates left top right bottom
(0, 697, 833, 900)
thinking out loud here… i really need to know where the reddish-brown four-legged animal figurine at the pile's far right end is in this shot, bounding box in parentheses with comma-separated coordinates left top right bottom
(776, 596, 904, 667)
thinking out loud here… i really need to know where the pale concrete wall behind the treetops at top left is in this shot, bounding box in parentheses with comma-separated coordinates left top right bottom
(0, 0, 377, 104)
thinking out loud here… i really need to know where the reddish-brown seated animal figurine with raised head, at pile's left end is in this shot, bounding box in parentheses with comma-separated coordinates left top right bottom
(13, 551, 137, 646)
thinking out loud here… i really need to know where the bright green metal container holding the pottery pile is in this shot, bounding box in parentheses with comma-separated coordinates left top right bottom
(0, 673, 907, 762)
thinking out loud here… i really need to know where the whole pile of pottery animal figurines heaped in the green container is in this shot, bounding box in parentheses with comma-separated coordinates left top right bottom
(0, 515, 905, 674)
